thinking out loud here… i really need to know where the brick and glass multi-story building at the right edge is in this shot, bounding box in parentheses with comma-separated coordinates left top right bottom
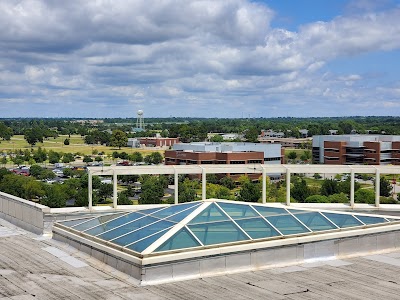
(312, 135, 400, 165)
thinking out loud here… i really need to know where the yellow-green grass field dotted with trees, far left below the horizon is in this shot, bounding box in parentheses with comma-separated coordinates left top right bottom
(0, 135, 164, 155)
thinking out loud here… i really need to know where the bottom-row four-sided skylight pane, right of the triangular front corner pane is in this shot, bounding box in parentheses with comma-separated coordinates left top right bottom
(188, 221, 249, 245)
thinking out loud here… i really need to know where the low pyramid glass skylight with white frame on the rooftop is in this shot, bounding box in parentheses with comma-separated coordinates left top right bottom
(59, 200, 400, 255)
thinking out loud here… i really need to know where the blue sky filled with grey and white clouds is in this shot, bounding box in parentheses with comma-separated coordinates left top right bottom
(0, 0, 400, 118)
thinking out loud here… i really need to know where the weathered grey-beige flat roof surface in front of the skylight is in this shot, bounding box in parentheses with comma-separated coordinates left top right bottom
(0, 219, 400, 300)
